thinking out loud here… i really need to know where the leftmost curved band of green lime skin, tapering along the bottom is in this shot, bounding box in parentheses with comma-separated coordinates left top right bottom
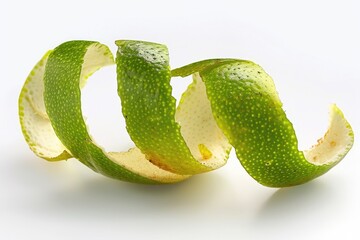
(44, 41, 156, 183)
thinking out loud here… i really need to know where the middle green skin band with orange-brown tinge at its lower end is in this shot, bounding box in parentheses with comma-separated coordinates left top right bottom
(116, 41, 208, 174)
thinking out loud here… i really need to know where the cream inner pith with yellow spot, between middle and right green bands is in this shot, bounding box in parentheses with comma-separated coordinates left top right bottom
(175, 73, 231, 169)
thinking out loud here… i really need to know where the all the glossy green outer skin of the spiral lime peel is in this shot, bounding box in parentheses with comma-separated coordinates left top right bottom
(19, 41, 353, 187)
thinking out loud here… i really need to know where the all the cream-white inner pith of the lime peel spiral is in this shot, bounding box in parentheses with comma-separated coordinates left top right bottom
(19, 41, 354, 183)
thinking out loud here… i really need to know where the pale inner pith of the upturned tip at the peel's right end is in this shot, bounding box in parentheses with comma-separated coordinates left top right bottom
(303, 105, 354, 165)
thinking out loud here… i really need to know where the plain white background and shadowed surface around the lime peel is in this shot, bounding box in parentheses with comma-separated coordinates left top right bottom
(0, 0, 360, 239)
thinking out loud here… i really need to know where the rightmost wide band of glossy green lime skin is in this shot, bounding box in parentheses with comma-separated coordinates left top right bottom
(172, 59, 337, 187)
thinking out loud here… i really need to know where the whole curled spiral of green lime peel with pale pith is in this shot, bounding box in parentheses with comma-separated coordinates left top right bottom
(19, 40, 354, 187)
